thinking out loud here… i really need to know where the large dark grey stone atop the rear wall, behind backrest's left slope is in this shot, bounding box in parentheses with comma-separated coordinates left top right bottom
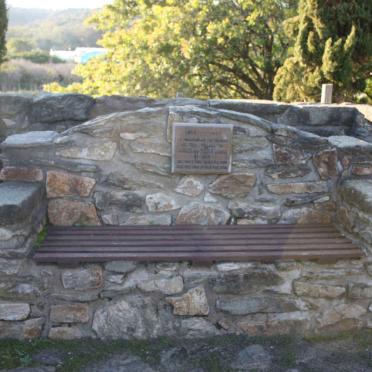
(31, 94, 94, 123)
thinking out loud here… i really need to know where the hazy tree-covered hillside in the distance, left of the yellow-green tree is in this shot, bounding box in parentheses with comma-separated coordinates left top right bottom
(7, 8, 100, 51)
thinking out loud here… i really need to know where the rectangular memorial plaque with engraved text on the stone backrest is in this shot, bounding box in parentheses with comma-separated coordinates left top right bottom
(172, 123, 233, 174)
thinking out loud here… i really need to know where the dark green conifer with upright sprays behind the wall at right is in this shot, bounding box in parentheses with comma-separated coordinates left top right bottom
(274, 0, 372, 101)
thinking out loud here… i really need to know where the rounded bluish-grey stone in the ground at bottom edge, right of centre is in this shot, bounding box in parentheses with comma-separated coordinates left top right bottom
(231, 345, 272, 371)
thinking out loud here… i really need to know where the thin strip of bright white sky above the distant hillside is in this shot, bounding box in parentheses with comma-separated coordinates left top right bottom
(6, 0, 113, 9)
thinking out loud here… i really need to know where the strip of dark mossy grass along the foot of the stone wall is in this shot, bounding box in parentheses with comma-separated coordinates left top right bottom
(0, 330, 372, 372)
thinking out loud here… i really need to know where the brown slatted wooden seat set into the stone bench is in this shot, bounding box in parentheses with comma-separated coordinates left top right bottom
(34, 224, 363, 263)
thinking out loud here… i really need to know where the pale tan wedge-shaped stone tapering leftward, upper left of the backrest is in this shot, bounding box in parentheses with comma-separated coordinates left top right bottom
(57, 141, 117, 161)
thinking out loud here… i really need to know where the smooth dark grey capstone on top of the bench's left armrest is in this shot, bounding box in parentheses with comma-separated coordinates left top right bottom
(0, 182, 43, 225)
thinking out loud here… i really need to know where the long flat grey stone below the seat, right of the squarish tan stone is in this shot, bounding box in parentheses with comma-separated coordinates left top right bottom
(216, 296, 306, 315)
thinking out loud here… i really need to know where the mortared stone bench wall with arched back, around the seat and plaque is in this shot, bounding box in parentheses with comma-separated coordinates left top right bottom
(0, 97, 372, 339)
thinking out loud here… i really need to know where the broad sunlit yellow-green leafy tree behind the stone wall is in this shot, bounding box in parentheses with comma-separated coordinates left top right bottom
(46, 0, 296, 99)
